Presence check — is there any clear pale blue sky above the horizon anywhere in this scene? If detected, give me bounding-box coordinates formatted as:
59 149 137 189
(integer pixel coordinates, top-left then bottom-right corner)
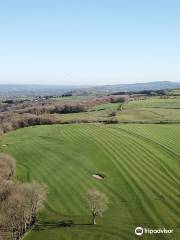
0 0 180 85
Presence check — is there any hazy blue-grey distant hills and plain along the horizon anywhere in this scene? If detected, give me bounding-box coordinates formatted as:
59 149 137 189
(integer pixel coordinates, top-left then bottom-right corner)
0 81 180 98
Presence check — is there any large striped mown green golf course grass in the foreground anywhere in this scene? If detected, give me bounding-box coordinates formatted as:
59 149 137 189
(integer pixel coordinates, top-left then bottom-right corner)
0 124 180 240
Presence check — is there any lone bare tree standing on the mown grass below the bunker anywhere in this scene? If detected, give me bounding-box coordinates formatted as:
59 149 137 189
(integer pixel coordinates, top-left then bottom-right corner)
86 190 108 224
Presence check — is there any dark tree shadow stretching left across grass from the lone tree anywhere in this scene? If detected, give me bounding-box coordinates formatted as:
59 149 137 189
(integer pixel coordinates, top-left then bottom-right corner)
34 220 92 231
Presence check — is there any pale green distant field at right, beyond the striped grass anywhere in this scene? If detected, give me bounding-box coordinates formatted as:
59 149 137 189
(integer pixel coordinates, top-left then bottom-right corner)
117 97 180 122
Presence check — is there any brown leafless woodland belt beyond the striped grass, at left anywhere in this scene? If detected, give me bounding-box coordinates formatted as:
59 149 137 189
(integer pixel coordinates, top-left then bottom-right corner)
0 95 129 134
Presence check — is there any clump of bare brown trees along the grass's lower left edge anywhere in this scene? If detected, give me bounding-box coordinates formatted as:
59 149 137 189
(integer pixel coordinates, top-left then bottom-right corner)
0 154 47 240
